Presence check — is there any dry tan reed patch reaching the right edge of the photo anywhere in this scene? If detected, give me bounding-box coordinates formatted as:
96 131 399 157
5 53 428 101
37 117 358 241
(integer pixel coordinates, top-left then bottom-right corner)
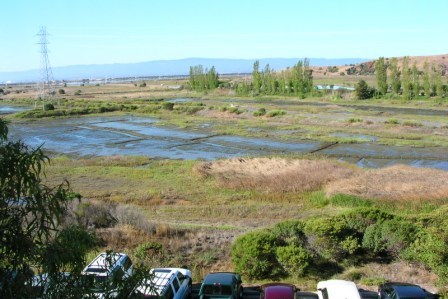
326 165 448 200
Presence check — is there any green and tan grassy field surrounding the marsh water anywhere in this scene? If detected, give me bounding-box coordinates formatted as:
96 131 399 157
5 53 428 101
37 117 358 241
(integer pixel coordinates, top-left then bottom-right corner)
1 76 448 289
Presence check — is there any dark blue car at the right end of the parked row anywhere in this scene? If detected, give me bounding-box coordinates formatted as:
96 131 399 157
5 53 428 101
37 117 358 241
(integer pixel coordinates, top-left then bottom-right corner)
378 282 438 299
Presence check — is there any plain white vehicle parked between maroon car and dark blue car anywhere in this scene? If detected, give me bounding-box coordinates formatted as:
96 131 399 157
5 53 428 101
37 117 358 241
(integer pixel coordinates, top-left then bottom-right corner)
317 279 362 299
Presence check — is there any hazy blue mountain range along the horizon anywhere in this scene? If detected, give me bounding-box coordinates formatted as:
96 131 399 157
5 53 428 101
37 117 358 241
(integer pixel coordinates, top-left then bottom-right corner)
0 58 369 83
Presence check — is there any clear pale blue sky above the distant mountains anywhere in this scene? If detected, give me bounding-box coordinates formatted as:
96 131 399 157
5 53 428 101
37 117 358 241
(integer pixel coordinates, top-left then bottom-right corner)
0 0 448 72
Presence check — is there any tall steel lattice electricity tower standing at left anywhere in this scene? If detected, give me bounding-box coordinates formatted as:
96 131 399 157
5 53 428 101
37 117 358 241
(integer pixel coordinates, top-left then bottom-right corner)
35 27 56 110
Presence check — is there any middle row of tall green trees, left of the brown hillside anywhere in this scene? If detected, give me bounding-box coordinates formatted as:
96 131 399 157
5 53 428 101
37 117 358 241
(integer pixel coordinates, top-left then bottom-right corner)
235 59 313 98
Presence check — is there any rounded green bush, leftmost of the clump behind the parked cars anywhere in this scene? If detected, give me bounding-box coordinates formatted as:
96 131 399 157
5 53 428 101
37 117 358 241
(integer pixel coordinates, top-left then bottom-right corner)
231 231 282 279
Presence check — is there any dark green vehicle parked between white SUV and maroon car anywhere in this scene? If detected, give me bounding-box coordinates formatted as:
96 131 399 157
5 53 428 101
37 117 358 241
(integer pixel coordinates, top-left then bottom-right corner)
199 272 244 299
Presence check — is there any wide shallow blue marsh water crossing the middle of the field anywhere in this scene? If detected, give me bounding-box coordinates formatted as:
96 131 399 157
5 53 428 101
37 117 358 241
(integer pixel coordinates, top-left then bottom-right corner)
9 110 448 171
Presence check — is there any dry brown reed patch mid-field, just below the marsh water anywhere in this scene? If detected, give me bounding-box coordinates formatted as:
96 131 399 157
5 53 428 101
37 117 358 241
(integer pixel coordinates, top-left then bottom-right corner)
194 158 357 192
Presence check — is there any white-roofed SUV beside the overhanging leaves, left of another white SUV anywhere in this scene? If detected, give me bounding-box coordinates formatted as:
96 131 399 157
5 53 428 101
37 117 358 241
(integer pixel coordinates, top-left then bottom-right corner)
81 252 134 298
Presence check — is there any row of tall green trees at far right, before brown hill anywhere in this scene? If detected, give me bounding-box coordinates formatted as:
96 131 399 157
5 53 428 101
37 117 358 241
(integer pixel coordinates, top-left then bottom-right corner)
375 57 446 100
